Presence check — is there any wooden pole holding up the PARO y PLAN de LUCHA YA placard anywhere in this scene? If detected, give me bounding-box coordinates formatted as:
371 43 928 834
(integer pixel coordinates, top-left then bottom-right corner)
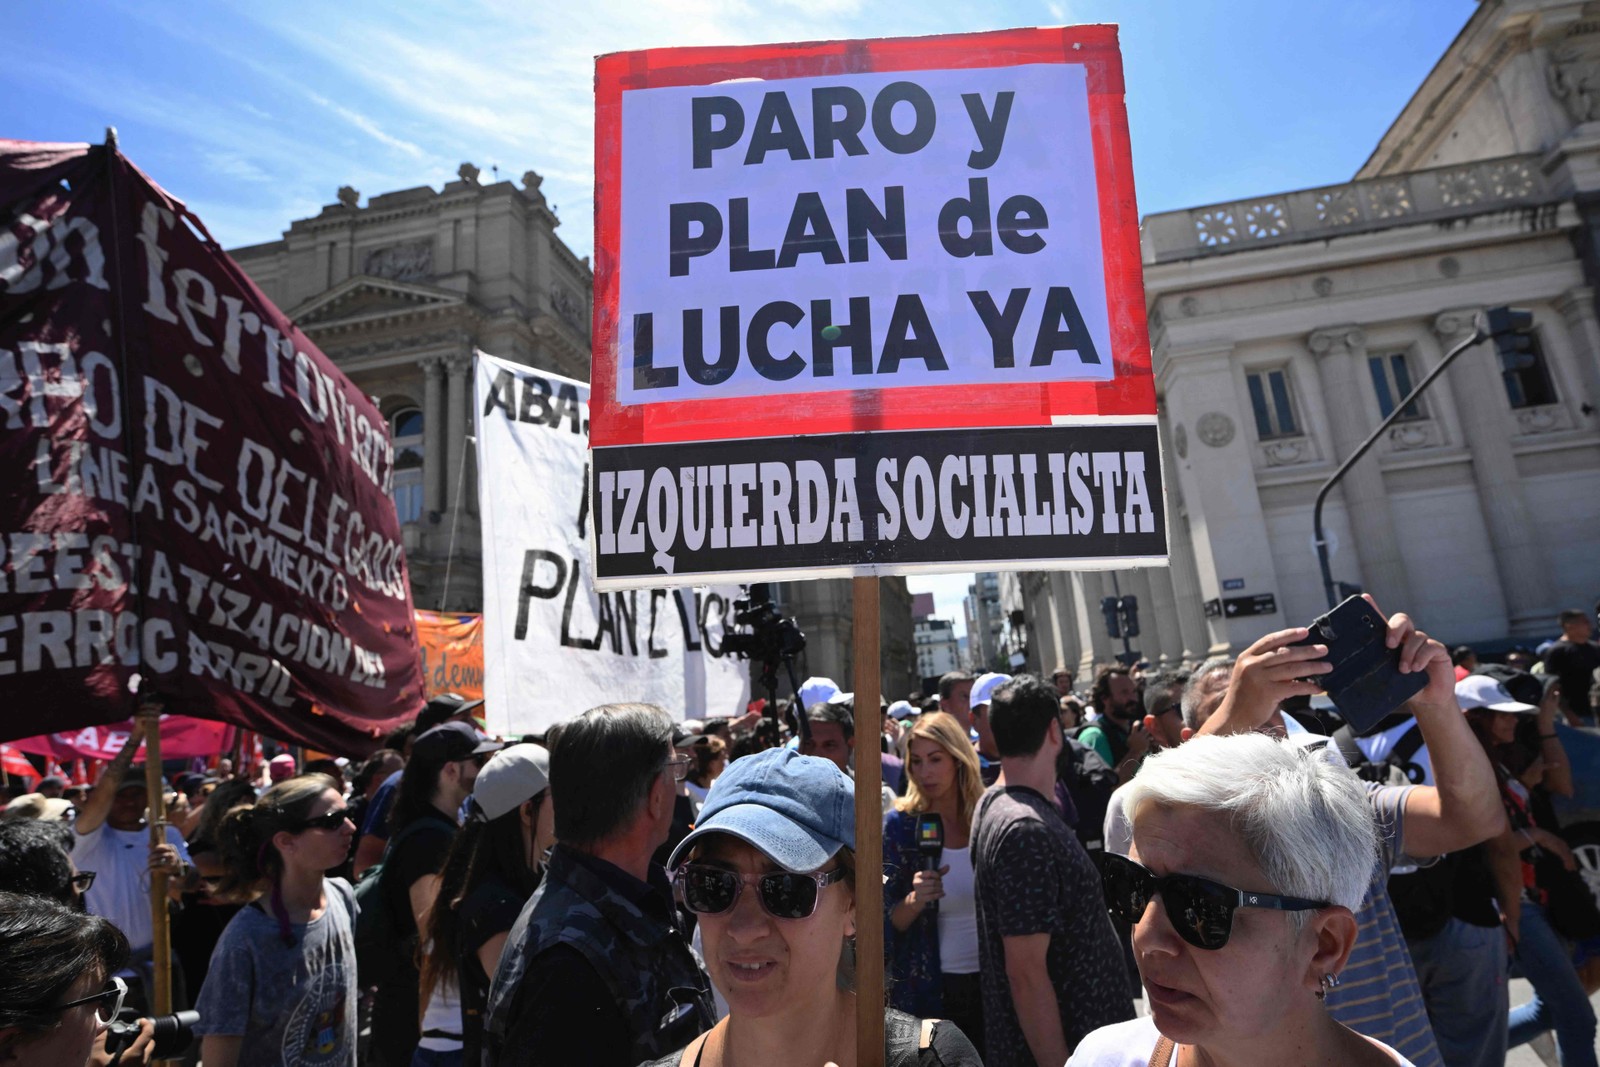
851 577 883 1067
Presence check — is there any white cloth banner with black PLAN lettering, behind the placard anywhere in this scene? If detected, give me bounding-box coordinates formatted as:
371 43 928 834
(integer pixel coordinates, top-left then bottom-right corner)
474 352 750 734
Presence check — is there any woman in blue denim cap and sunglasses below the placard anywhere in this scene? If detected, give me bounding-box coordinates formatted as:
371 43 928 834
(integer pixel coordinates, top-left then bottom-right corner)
633 749 981 1067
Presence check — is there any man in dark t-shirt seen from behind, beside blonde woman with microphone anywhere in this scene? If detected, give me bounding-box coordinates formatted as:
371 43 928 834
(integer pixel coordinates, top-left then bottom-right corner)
973 675 1133 1067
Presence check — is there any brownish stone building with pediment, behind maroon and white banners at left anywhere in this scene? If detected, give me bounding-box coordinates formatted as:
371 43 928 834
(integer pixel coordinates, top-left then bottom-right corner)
229 171 917 696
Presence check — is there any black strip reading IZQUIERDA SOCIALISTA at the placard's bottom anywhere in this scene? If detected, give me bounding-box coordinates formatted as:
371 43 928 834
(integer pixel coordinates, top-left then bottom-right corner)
590 426 1166 584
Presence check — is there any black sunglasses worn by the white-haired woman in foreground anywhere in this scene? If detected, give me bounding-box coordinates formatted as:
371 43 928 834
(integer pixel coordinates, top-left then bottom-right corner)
1096 853 1330 949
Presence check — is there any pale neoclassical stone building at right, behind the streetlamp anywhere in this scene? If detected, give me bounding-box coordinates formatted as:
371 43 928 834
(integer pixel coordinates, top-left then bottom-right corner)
1006 0 1600 669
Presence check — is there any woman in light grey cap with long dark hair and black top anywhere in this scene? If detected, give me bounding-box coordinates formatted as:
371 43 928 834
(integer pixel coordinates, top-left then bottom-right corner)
416 744 555 1067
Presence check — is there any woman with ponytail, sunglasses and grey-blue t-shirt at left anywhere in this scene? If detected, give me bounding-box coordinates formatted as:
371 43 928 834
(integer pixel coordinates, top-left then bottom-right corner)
195 774 357 1067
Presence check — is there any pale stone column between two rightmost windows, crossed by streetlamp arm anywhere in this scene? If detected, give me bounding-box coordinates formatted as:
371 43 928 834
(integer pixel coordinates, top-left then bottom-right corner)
1433 307 1555 637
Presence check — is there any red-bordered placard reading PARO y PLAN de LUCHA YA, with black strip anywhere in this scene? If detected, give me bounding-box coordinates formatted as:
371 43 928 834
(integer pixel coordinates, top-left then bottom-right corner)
592 26 1166 589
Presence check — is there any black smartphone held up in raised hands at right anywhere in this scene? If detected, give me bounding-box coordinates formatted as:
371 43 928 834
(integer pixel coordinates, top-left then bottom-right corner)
1294 597 1427 734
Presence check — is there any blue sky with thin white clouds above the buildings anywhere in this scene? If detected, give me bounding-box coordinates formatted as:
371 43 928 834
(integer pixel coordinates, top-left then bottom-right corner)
0 0 1475 630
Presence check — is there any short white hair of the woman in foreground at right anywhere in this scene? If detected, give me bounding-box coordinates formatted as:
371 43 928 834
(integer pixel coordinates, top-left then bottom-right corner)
1123 733 1378 929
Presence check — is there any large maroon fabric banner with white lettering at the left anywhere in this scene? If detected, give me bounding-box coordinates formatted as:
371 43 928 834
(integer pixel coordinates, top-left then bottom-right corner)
0 141 422 755
